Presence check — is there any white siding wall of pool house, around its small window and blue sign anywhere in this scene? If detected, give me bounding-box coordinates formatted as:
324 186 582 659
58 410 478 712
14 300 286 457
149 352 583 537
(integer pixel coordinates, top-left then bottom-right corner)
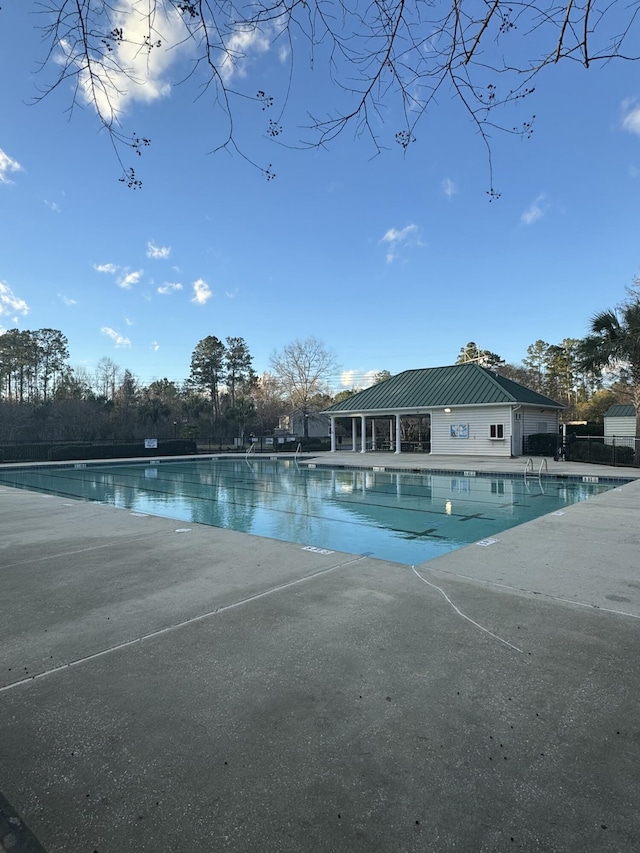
431 406 511 456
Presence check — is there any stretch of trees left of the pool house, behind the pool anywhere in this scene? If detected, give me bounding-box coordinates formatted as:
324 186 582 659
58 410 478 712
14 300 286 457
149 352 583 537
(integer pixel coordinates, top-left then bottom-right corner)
0 329 337 443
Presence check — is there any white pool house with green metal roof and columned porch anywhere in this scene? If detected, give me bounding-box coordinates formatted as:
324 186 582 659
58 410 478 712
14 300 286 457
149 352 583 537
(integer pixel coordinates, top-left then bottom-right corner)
324 363 563 456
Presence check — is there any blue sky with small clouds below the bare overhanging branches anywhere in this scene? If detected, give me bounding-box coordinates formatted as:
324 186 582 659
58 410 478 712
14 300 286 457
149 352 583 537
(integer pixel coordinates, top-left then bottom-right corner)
0 2 640 390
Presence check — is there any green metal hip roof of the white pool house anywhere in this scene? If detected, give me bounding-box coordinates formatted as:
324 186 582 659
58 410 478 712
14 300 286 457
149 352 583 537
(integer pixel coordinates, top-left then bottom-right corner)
326 364 563 415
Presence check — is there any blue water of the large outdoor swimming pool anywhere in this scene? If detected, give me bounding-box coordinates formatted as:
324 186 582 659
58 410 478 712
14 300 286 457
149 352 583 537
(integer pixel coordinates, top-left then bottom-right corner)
0 458 624 565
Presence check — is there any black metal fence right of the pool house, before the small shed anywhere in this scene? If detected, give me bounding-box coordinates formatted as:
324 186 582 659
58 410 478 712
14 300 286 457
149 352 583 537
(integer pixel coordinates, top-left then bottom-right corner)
522 433 640 467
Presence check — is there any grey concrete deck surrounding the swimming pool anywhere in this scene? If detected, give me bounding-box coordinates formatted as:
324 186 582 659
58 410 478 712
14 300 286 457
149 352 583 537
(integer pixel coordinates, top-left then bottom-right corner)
0 452 640 853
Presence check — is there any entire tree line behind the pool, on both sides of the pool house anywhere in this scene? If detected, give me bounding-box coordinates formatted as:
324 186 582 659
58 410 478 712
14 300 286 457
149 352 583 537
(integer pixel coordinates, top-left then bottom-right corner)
0 291 640 443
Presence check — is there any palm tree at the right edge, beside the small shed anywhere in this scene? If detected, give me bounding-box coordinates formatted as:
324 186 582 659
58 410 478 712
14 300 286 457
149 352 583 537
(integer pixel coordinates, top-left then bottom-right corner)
578 298 640 438
